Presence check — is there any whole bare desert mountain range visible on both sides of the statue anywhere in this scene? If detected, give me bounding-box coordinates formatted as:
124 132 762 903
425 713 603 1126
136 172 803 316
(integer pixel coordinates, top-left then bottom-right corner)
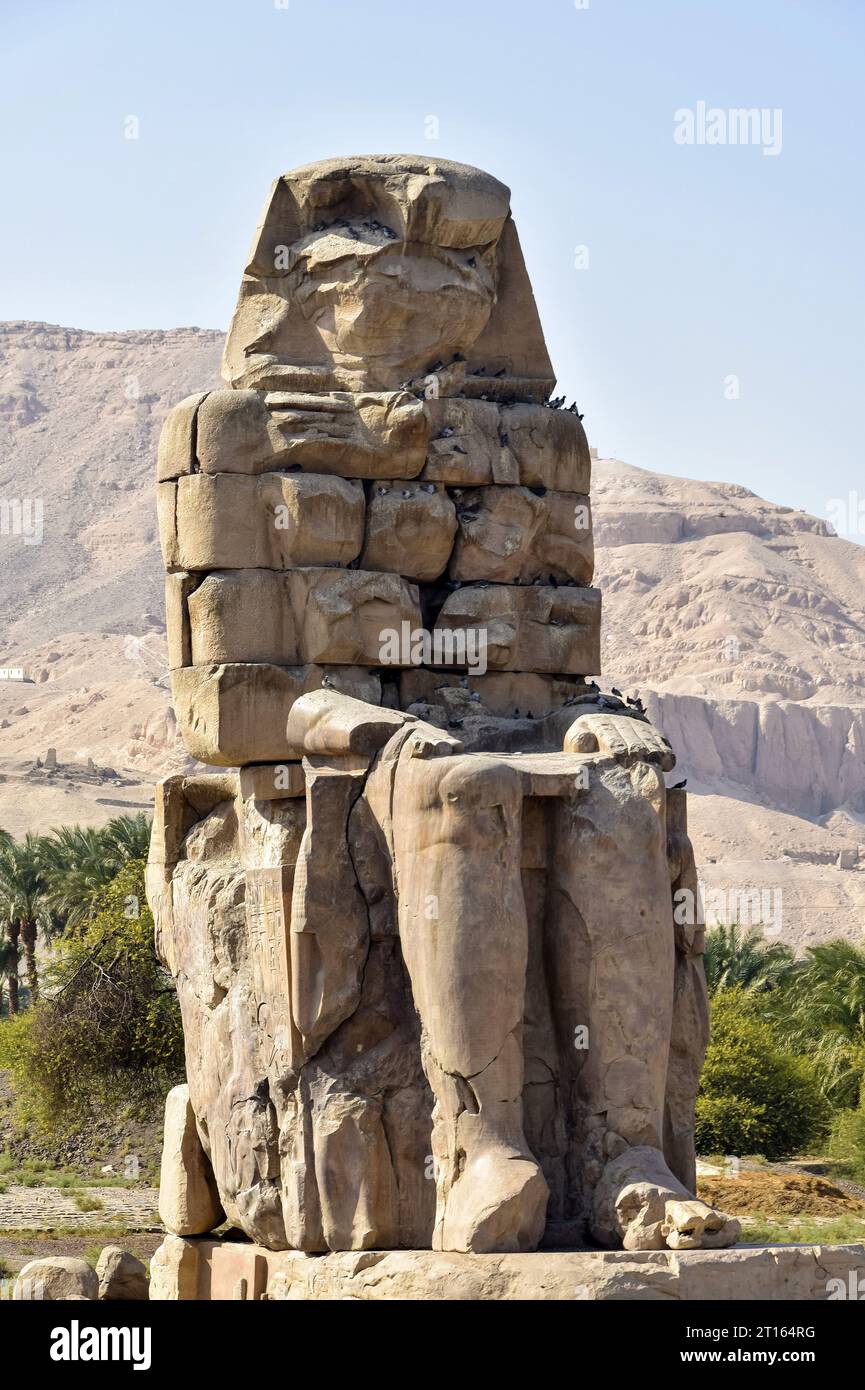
0 322 865 941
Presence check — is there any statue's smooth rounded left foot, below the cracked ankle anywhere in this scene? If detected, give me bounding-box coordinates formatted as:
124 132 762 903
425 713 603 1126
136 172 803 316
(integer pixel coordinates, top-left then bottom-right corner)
441 1148 549 1255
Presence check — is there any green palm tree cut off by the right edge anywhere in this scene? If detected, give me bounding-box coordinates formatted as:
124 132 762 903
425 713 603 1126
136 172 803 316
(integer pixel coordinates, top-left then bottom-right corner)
779 937 865 1108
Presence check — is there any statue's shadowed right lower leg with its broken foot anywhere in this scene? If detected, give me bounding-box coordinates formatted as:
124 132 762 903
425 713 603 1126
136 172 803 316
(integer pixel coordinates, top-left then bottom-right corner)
549 762 738 1250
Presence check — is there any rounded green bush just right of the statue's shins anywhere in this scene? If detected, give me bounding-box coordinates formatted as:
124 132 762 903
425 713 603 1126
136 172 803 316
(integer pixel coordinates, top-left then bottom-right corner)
697 987 827 1159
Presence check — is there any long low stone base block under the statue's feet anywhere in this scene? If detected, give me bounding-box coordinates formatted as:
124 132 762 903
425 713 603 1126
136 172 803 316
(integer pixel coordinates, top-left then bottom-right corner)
150 1236 865 1302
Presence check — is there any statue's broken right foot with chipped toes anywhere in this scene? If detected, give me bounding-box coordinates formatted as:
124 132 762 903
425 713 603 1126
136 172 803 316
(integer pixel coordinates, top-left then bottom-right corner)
591 1147 741 1250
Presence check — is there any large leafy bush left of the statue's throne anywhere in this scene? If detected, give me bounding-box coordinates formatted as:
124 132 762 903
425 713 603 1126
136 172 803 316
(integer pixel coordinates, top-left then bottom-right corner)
0 860 184 1127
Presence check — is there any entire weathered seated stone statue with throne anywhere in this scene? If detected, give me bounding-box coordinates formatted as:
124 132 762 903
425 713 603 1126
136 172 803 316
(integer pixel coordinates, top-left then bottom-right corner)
149 156 738 1252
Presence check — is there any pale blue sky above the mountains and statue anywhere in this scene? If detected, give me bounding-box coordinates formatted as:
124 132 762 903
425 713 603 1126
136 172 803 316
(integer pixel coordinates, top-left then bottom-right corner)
0 0 865 516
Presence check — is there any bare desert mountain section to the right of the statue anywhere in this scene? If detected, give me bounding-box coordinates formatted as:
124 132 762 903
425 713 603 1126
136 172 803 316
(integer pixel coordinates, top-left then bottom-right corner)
592 459 865 942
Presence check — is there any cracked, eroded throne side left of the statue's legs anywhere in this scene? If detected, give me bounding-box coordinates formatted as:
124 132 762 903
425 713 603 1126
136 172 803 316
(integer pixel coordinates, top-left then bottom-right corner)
149 765 435 1251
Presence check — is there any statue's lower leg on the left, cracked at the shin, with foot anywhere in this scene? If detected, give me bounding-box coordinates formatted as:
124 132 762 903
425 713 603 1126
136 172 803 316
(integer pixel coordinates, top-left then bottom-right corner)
394 755 548 1251
